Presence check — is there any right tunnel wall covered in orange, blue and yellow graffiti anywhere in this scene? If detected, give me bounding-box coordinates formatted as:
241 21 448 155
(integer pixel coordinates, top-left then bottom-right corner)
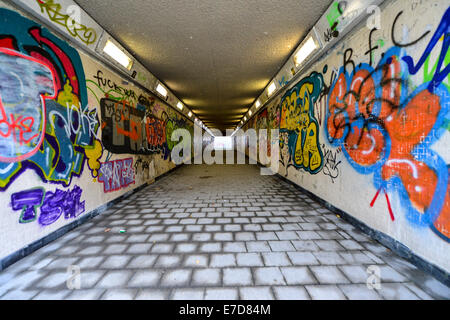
243 0 450 272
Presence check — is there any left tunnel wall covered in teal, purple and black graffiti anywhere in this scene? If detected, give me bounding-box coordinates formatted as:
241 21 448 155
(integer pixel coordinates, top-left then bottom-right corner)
0 5 194 259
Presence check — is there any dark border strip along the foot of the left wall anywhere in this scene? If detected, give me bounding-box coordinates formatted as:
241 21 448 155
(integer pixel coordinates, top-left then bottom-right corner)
0 164 184 271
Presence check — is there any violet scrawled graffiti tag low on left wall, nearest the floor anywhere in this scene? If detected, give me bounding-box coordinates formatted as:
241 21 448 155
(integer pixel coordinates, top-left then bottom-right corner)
11 186 85 226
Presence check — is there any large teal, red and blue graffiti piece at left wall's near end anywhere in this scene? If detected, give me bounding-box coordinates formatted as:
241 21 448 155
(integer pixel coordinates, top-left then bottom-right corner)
0 9 99 190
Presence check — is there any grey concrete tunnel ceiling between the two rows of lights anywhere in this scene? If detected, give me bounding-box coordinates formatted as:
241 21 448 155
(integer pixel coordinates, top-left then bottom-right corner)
76 0 333 130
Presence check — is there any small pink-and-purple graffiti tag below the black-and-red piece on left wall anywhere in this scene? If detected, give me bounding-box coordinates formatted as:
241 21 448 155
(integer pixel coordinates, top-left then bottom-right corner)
98 158 134 192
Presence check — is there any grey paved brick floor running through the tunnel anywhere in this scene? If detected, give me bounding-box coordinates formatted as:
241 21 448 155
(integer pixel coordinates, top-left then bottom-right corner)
0 165 450 299
